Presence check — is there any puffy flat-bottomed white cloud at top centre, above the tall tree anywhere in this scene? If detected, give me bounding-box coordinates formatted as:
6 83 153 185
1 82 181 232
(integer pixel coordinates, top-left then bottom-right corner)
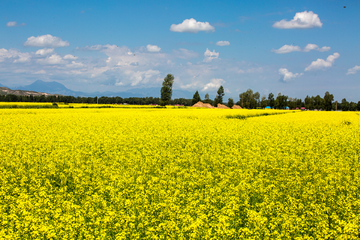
170 18 215 33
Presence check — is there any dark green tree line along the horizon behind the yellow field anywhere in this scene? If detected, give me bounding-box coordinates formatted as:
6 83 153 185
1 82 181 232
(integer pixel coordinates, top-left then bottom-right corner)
0 86 360 111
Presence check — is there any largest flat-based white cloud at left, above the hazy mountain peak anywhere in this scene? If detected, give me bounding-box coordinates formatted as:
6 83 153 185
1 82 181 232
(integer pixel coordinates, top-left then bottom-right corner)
24 34 70 48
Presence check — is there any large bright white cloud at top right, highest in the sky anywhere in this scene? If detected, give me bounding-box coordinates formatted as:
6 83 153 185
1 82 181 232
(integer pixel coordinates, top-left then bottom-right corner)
273 11 322 29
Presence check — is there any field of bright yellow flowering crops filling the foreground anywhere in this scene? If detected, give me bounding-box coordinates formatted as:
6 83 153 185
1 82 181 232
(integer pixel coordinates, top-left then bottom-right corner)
0 108 360 239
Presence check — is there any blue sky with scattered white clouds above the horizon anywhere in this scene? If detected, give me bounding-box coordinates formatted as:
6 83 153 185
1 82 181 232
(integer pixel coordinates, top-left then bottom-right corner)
0 0 360 101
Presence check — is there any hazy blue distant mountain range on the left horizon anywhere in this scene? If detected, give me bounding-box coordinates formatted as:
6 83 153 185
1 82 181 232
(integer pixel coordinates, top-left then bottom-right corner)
11 80 194 99
